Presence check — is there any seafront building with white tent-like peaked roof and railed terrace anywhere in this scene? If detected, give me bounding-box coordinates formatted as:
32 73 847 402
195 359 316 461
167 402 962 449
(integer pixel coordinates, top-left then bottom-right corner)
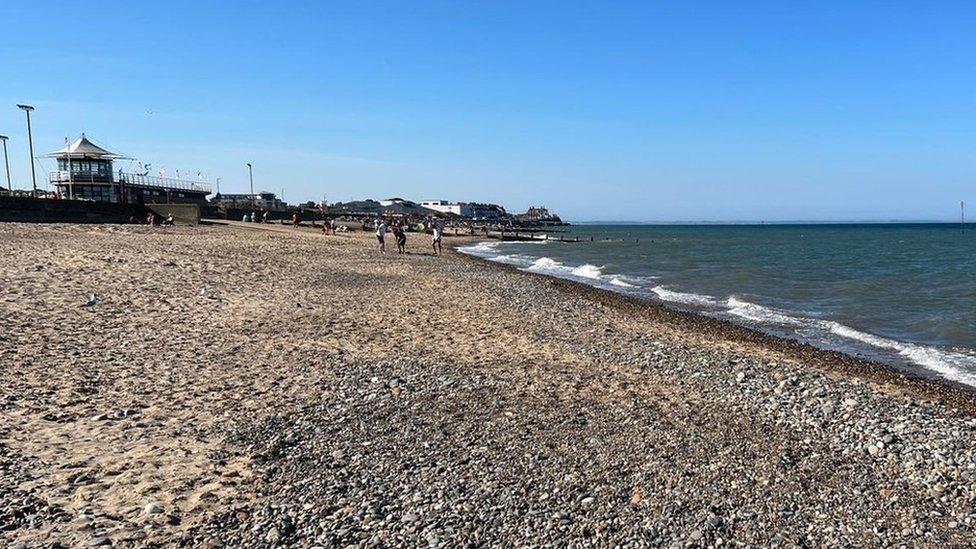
47 134 210 204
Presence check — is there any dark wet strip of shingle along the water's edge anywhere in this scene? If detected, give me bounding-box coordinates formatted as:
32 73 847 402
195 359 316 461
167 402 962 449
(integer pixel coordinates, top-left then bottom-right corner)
451 239 976 414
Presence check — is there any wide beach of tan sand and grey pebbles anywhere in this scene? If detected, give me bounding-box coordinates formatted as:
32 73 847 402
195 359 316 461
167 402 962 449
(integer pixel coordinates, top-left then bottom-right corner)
0 223 976 547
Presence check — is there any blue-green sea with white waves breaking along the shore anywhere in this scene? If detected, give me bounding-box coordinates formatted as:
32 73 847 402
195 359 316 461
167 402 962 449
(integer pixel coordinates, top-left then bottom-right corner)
459 223 976 387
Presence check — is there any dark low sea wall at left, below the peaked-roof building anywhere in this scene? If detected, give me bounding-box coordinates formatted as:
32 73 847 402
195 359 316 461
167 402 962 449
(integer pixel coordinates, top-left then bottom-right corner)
0 196 147 223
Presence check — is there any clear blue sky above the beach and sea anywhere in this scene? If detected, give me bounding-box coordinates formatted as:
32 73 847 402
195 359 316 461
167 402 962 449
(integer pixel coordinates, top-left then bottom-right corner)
0 0 976 221
